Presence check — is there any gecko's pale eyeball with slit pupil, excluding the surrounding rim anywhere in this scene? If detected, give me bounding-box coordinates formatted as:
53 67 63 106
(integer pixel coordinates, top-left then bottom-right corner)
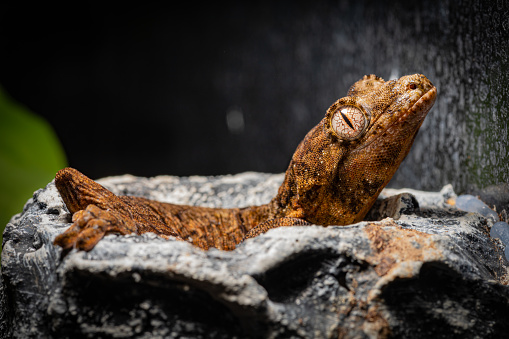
330 106 368 140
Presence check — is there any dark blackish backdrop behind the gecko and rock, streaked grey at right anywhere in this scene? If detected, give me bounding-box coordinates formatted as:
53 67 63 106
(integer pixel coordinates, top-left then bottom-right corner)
0 0 509 192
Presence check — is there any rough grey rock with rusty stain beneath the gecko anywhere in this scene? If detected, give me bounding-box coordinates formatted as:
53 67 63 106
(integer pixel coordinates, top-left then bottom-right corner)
0 173 509 338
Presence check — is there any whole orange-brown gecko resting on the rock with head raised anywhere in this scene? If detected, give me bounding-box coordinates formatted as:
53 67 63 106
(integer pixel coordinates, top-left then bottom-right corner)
54 74 437 251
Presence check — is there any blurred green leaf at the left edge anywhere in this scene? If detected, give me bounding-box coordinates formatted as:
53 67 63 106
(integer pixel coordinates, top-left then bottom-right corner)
0 87 67 247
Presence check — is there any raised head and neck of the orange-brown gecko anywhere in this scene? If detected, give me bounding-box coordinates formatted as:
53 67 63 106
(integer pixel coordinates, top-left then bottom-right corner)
277 74 437 225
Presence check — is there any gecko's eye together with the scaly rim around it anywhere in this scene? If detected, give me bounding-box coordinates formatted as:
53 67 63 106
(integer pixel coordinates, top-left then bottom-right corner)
326 97 370 140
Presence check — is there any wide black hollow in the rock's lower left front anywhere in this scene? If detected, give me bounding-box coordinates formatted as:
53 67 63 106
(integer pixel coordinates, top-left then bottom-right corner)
54 270 249 338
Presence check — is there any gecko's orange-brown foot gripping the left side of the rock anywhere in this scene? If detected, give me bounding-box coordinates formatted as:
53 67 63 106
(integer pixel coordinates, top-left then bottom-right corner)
53 205 136 252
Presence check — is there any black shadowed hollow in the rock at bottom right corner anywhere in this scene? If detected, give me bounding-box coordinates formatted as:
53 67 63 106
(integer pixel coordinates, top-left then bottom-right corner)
381 262 509 338
